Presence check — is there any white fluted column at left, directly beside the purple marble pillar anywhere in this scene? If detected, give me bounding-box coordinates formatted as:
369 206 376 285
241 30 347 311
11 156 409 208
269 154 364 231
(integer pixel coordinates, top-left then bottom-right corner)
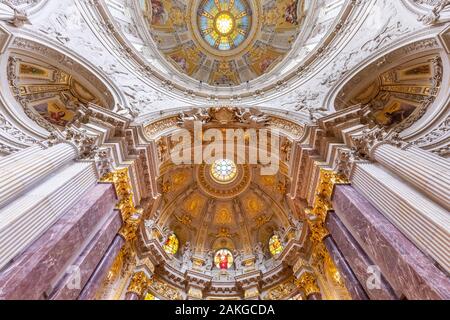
0 161 98 269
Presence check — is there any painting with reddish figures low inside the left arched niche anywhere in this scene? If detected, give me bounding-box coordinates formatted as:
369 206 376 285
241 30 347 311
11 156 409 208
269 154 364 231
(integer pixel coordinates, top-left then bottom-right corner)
29 98 75 128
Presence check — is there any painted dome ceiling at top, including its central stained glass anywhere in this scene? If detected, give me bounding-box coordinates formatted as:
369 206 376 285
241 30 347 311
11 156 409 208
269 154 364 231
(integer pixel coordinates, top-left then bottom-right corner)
140 0 305 86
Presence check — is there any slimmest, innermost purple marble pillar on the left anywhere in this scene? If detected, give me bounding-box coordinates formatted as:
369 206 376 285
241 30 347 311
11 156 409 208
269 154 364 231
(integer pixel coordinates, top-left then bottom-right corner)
78 235 125 300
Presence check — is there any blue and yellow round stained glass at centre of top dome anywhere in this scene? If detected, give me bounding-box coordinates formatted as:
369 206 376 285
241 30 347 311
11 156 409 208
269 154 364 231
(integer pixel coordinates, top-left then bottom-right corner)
198 0 252 51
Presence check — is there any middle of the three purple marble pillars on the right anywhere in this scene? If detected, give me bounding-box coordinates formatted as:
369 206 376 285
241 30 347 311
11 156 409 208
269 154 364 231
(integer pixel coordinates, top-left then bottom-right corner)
326 212 399 300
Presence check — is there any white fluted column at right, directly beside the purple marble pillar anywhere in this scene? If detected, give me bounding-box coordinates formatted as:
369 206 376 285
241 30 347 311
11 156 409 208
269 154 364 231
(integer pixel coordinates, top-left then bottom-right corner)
352 163 450 272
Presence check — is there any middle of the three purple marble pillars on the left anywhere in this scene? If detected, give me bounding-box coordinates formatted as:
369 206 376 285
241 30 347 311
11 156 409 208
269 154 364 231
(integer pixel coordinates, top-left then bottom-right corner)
50 211 122 300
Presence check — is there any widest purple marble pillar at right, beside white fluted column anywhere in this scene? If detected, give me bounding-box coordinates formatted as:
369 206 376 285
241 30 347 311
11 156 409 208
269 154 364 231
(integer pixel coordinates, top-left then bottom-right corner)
333 186 450 300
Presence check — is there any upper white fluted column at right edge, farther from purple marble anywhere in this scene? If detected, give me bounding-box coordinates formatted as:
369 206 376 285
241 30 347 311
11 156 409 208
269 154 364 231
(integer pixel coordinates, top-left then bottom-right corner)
372 144 450 210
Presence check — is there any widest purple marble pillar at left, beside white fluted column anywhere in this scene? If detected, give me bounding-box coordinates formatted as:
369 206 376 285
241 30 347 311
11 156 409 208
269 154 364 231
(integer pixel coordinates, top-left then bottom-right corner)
0 184 117 300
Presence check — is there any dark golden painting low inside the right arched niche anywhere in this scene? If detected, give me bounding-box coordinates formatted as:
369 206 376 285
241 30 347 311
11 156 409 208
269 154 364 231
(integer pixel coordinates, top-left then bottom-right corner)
372 100 417 127
